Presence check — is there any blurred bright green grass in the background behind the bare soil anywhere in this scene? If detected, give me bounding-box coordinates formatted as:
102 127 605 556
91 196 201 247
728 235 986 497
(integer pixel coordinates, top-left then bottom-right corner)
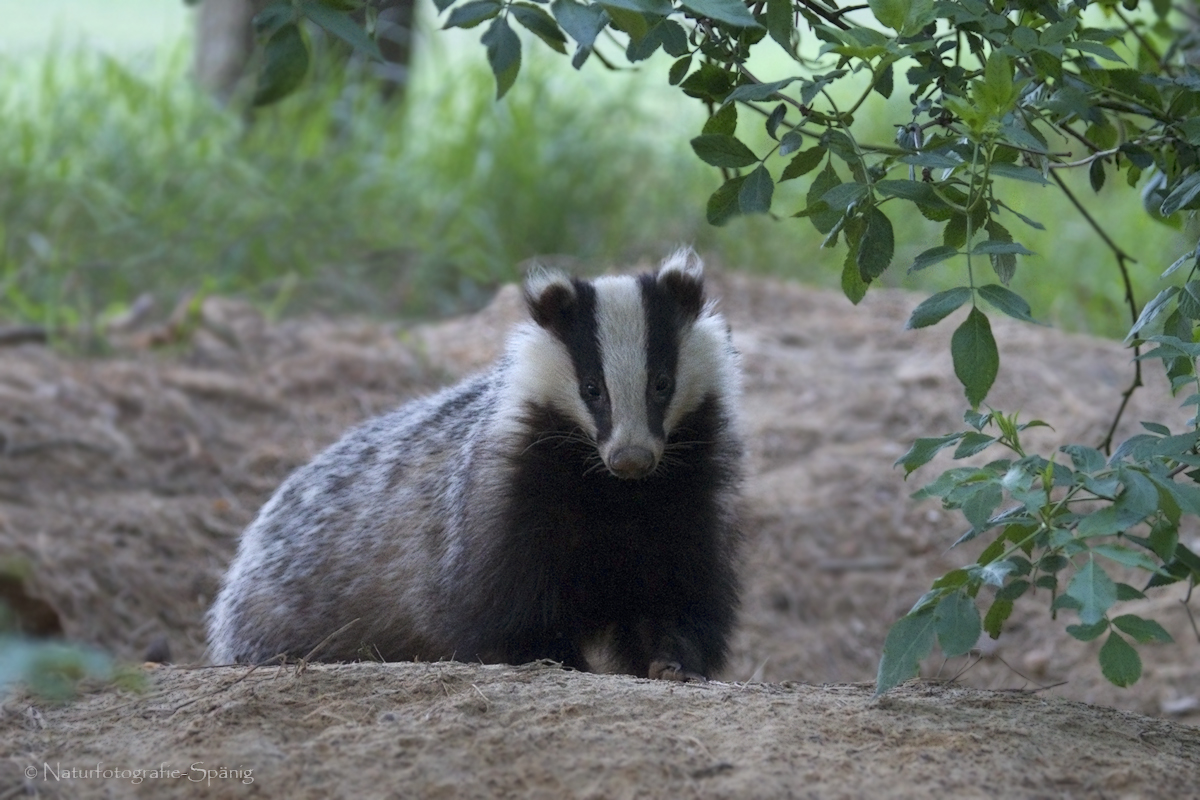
0 24 1184 336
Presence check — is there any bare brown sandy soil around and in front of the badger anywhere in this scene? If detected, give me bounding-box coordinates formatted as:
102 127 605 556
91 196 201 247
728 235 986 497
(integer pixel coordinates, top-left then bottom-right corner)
0 276 1200 798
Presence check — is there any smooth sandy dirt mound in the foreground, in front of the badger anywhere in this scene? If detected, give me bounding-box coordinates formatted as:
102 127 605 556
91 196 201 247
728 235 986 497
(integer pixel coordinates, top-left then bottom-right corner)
9 663 1200 800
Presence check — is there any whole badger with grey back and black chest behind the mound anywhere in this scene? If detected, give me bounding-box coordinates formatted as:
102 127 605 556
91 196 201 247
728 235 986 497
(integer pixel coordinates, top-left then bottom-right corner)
209 249 743 680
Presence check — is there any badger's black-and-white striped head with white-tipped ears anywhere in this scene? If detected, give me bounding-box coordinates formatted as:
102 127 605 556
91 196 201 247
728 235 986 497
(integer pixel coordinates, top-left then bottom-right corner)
501 249 738 480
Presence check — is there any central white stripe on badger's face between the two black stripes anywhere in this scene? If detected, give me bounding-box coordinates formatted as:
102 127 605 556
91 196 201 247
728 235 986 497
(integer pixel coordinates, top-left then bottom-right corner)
595 277 662 456
